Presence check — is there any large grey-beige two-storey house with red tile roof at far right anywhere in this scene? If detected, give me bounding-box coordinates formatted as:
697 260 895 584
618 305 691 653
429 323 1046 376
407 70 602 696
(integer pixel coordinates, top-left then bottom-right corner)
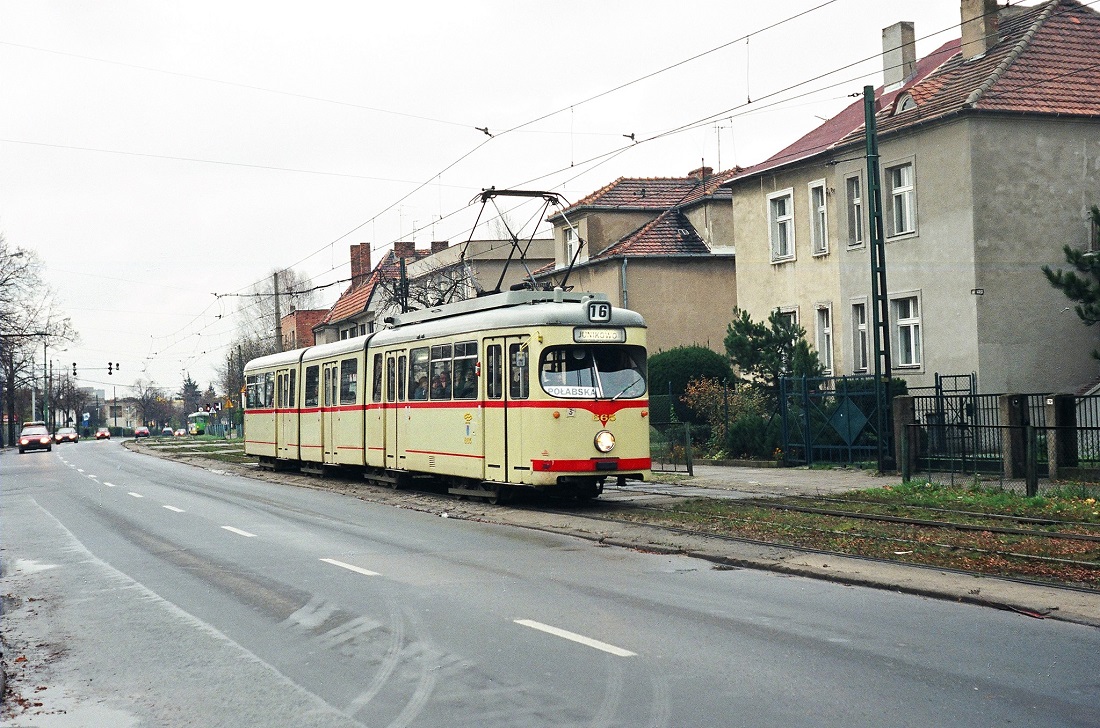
726 0 1100 393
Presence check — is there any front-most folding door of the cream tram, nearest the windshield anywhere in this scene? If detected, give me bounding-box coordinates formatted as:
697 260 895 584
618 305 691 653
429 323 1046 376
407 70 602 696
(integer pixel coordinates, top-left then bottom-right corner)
484 337 531 483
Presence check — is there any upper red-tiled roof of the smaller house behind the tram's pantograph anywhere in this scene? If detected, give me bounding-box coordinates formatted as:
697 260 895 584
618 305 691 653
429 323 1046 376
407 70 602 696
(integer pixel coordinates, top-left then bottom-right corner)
548 168 739 222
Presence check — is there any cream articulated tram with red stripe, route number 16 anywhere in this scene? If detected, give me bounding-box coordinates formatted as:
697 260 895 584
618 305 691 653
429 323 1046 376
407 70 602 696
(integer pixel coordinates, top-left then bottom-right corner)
244 288 650 501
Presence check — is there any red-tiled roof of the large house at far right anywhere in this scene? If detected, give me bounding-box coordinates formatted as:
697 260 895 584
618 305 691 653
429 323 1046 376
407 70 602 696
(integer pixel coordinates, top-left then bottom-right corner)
740 0 1100 177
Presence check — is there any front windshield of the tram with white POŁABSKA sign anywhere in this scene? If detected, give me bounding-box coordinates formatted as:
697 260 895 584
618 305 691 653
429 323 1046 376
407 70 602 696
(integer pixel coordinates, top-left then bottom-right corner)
539 344 646 399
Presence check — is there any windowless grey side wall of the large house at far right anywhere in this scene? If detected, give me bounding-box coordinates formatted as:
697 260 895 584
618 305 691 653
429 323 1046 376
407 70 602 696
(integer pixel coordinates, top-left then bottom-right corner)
969 118 1100 391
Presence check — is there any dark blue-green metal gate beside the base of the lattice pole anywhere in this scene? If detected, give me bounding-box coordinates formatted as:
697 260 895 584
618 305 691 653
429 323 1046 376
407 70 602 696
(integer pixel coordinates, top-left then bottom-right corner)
779 376 892 465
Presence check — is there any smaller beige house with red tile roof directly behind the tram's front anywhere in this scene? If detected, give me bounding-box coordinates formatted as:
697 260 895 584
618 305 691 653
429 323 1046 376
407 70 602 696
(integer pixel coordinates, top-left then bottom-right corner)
534 167 737 352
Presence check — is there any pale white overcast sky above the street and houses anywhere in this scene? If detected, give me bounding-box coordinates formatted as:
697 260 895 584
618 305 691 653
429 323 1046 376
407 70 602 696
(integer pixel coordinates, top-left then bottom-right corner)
0 0 994 396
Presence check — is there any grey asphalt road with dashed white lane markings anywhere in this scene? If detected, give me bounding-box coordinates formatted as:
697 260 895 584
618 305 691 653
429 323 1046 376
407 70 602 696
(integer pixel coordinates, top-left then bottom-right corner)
0 441 1100 728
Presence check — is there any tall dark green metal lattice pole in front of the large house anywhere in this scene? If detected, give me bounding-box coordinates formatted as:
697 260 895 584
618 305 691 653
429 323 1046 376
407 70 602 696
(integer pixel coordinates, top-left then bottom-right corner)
864 86 894 473
